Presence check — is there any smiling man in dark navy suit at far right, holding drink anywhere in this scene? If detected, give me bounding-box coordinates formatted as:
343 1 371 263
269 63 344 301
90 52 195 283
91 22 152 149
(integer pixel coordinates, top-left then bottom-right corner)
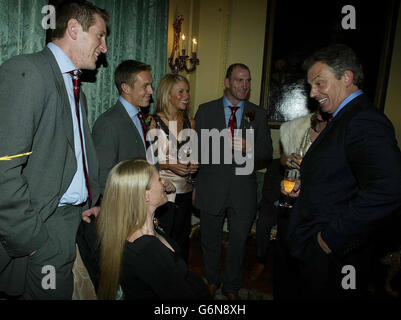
288 44 401 299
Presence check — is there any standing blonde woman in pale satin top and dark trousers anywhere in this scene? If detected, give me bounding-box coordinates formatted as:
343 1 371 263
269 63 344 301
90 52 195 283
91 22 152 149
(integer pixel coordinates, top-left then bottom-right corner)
150 73 199 262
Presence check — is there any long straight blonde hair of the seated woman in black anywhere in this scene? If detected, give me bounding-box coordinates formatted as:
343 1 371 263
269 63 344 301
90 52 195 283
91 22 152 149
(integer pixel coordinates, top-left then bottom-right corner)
97 158 156 299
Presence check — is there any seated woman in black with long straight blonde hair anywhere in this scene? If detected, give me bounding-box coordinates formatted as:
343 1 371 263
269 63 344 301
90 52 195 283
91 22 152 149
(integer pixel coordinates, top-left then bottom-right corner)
97 159 210 300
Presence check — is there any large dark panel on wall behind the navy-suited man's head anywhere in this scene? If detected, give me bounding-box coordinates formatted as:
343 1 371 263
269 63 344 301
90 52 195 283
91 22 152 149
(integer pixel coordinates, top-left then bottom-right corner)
265 0 399 121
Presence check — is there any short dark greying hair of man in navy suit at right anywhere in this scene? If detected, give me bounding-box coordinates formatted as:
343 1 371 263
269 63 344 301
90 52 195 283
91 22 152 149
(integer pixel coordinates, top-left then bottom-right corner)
303 43 364 88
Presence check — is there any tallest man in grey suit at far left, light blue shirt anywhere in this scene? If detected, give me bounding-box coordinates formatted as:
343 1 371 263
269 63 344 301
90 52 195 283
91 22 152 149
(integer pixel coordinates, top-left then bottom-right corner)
0 1 108 299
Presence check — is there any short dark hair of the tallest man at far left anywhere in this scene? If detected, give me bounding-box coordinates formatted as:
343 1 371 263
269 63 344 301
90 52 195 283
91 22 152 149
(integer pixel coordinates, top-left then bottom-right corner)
52 0 110 39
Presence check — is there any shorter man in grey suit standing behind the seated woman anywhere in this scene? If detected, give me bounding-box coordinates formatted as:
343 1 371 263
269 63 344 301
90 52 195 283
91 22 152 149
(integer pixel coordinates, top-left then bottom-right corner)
92 60 153 190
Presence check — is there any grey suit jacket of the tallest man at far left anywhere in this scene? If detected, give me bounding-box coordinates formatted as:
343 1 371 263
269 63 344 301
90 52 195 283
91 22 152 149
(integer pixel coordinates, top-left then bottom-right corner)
0 48 99 294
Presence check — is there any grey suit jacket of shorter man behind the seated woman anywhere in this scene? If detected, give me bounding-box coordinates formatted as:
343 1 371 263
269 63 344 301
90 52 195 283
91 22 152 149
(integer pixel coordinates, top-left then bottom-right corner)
92 100 146 193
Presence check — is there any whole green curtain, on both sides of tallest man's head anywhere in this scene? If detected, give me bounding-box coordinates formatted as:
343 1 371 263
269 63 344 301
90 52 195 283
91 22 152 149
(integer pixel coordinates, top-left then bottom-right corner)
0 0 168 126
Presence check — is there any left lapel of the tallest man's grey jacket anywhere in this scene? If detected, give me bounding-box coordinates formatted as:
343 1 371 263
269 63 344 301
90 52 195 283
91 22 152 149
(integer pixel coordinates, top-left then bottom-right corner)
43 48 75 152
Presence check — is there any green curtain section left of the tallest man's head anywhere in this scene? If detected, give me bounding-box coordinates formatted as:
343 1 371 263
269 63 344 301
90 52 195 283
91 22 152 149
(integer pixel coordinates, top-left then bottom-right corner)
0 0 47 65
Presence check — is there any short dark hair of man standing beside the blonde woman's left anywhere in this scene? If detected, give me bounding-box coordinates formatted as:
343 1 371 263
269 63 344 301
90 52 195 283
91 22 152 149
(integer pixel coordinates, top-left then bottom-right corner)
114 60 152 94
